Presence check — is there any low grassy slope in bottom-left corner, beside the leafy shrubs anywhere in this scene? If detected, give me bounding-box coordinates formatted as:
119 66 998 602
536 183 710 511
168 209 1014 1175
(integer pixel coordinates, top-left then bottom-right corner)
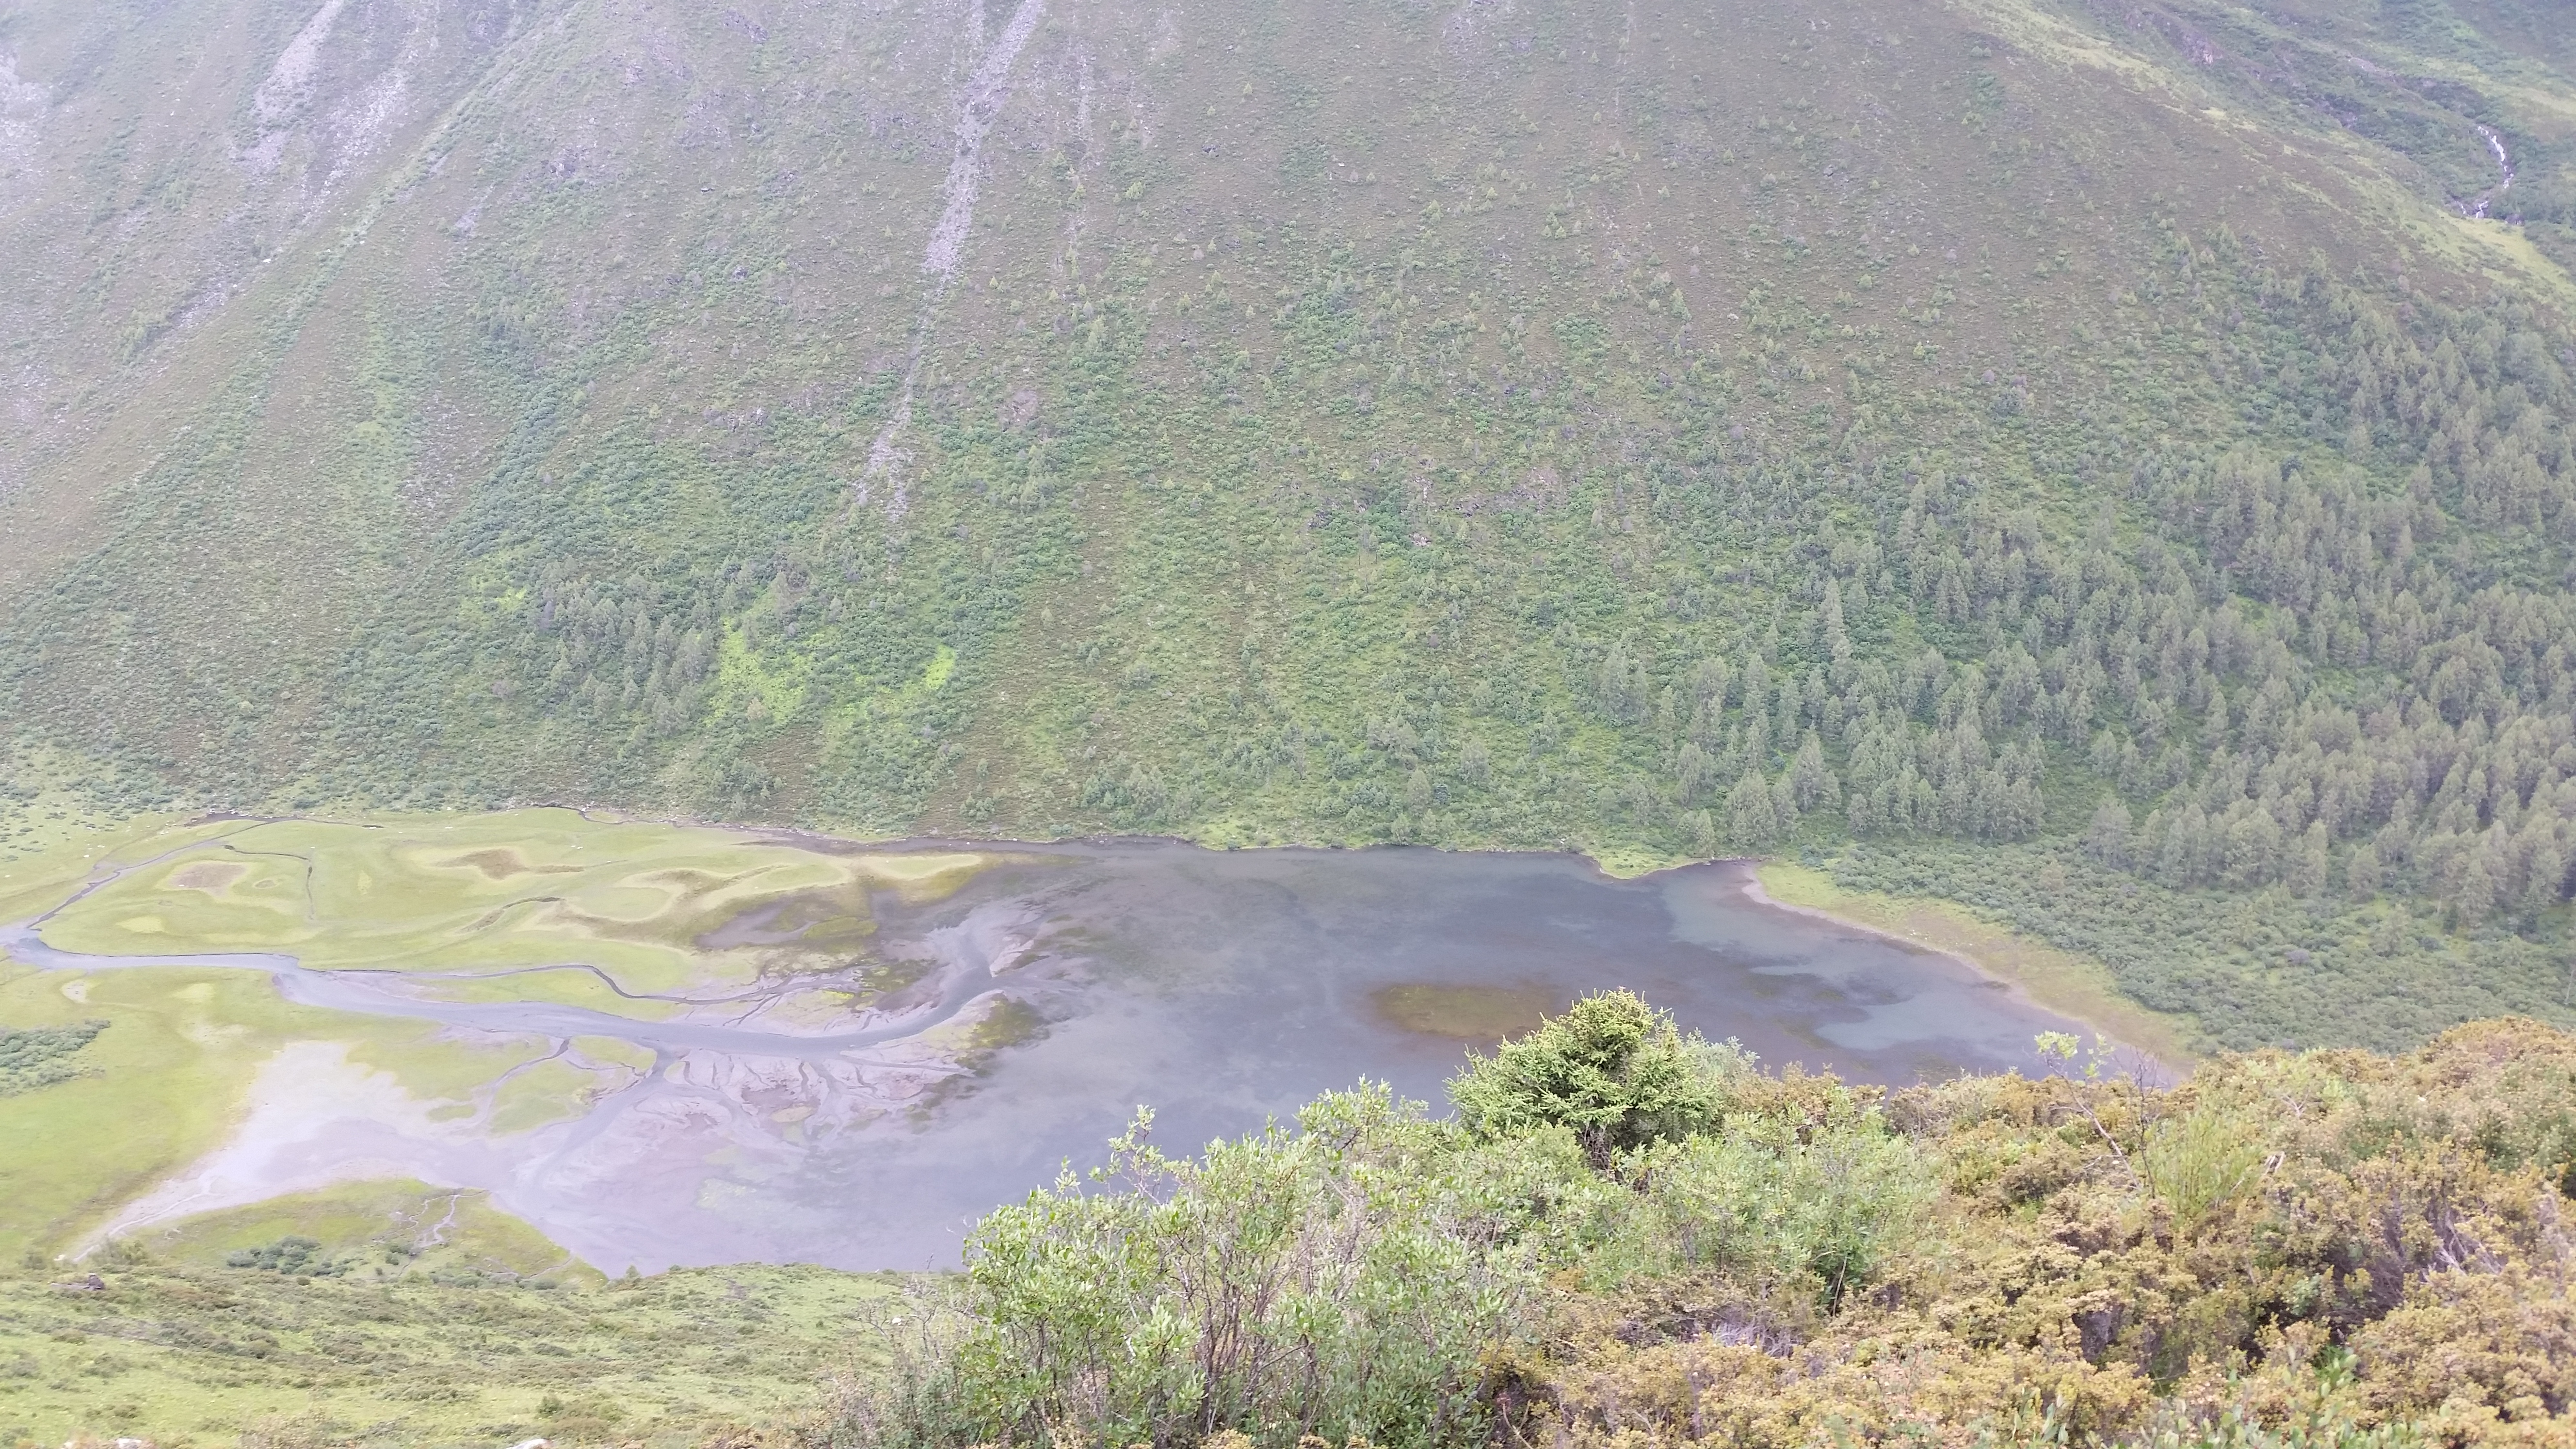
0 1238 889 1449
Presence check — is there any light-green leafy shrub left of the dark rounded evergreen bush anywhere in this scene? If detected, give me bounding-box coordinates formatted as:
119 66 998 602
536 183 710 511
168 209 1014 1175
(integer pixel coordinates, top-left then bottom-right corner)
842 1088 1538 1447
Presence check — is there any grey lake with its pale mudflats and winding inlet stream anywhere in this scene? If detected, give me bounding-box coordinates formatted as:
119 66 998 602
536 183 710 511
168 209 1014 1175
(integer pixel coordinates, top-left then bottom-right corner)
15 840 2076 1273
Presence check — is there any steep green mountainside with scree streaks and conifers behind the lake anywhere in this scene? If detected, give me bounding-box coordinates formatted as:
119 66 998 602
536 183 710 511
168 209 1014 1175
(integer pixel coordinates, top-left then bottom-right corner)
0 0 2576 1047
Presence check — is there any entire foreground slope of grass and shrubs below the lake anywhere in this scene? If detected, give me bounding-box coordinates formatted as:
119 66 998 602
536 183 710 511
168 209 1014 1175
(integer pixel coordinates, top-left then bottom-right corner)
0 993 2576 1449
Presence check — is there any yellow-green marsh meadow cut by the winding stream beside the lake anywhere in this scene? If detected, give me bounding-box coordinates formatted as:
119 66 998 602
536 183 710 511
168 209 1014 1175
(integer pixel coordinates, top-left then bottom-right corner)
0 809 1035 1256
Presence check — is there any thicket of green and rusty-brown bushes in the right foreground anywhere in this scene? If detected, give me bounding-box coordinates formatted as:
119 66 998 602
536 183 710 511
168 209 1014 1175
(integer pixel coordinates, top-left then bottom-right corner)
822 998 2576 1449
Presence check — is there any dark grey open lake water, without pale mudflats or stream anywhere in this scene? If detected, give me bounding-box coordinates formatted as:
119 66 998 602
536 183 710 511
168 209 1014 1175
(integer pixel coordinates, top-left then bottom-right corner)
783 843 2079 1266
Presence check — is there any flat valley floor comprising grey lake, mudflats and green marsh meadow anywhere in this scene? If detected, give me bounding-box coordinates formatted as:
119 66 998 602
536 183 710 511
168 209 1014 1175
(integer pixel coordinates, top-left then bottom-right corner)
0 809 2079 1273
